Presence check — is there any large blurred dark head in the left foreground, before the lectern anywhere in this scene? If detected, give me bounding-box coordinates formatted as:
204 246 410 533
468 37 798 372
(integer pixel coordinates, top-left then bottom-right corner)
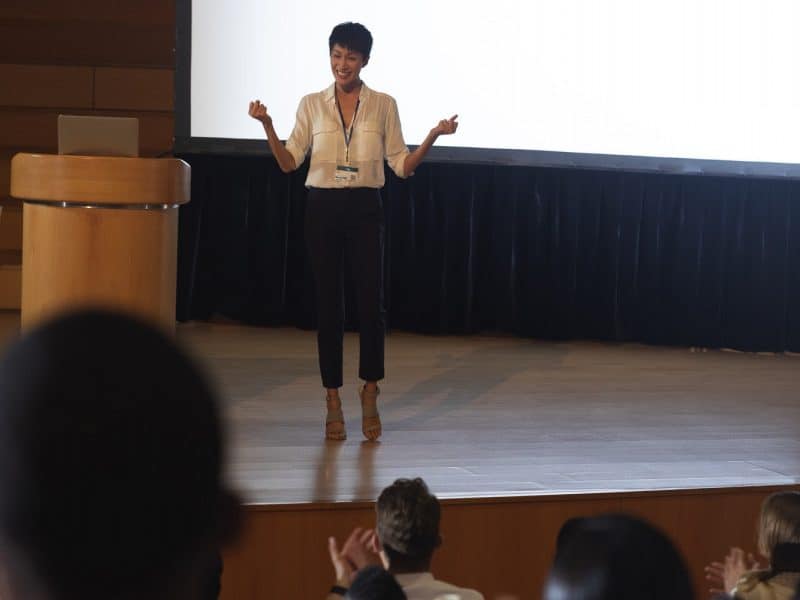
0 311 239 600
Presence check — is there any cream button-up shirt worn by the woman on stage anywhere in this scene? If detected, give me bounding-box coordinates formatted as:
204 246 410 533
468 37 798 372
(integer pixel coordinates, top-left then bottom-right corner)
286 83 409 188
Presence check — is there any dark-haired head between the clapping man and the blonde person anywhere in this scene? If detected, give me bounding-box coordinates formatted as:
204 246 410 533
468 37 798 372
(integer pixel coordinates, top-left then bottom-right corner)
544 515 693 600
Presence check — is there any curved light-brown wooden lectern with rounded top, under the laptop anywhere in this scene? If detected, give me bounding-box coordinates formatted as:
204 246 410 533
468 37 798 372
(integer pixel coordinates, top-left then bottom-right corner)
11 154 190 330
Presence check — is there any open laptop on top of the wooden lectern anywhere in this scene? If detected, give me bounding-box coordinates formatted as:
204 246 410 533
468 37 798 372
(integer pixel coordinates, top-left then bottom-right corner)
58 115 139 157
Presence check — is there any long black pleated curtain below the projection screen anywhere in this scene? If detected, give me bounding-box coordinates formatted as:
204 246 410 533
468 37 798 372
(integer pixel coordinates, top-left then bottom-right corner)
177 156 800 352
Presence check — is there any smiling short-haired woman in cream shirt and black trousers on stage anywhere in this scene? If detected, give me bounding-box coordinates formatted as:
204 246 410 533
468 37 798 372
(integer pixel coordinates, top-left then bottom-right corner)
249 23 458 441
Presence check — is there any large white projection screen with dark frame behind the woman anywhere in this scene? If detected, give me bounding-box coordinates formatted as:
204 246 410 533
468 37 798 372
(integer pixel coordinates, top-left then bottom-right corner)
176 0 800 178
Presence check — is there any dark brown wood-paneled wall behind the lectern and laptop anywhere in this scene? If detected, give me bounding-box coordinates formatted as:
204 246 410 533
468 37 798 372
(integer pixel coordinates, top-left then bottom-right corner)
0 0 175 304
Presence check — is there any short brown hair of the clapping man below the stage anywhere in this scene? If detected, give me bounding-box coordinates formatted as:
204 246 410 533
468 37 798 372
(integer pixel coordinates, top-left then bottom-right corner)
375 477 441 568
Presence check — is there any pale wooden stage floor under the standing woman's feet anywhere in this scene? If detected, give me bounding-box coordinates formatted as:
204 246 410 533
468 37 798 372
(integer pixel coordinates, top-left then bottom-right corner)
173 323 800 505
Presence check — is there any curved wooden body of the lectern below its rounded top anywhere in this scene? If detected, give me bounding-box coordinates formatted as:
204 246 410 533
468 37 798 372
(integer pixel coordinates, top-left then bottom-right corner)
22 202 178 328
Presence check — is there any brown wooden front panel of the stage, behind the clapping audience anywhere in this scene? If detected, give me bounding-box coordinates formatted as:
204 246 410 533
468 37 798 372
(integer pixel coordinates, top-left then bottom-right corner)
222 488 789 600
